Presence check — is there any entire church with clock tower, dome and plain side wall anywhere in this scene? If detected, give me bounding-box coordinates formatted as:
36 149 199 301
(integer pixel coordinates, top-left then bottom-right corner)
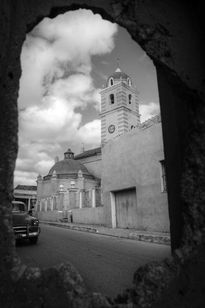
37 68 169 232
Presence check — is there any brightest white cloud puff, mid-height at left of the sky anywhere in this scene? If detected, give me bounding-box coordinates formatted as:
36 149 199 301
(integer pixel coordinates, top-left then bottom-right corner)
20 97 81 141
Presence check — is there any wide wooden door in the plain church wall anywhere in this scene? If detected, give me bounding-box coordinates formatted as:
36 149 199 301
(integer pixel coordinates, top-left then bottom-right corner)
115 188 137 228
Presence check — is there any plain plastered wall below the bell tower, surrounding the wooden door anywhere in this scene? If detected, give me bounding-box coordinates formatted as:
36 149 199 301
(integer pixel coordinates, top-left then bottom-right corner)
102 123 169 232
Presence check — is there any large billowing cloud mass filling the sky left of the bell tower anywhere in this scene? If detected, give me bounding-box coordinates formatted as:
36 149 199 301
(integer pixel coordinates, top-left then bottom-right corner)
15 10 117 185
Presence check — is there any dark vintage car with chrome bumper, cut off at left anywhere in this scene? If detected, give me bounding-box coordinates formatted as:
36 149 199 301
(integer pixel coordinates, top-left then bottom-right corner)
12 201 40 244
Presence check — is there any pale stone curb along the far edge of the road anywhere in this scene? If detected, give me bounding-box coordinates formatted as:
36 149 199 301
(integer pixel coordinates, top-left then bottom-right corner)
40 221 170 246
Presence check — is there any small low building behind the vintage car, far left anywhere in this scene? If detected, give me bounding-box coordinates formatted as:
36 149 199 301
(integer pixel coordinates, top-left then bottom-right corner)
14 185 37 211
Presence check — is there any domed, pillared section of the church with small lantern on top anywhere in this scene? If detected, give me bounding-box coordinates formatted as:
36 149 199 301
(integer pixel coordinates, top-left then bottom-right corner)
37 149 101 218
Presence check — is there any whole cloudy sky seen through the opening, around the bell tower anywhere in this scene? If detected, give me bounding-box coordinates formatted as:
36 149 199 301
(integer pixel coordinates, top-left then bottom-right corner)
14 10 159 186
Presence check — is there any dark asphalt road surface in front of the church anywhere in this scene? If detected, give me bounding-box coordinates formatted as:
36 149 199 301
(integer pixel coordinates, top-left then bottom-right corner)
16 225 170 298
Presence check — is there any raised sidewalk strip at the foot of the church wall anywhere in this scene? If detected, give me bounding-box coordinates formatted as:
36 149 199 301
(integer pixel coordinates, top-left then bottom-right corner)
40 221 170 245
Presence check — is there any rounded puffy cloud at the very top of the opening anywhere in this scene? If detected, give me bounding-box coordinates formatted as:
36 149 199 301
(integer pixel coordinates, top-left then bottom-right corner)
33 9 117 57
